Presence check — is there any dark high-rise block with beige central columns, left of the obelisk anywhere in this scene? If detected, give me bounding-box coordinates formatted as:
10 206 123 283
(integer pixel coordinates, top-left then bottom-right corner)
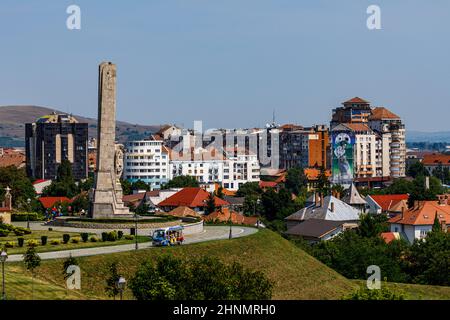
25 113 88 180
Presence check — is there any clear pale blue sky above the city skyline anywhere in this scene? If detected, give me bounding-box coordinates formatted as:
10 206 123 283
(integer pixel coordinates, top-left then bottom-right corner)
0 0 450 131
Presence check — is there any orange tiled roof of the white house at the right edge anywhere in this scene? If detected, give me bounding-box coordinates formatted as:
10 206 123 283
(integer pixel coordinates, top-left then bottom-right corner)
389 201 450 225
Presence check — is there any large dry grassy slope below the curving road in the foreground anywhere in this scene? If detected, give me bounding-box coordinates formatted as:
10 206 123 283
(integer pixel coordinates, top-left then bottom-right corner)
3 230 450 300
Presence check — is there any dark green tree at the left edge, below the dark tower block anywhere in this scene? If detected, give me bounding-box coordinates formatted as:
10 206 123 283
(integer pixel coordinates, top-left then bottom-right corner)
0 166 39 208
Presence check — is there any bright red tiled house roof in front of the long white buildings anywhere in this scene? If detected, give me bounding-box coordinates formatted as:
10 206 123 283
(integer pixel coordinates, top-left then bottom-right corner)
159 188 229 208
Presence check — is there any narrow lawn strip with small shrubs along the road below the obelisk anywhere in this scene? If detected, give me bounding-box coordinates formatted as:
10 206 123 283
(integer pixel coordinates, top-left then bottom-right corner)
0 233 151 255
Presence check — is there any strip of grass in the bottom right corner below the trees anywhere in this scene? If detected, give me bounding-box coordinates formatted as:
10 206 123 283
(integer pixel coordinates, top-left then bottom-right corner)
354 280 450 300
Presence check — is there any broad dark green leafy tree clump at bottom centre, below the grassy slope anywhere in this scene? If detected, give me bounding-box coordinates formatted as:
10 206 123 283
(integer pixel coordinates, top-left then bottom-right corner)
129 255 273 300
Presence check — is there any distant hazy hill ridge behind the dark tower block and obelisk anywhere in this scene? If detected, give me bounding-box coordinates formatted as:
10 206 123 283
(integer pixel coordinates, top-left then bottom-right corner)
0 106 161 147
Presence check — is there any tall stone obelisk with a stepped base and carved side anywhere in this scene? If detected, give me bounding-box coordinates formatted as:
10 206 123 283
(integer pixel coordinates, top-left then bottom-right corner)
90 62 130 219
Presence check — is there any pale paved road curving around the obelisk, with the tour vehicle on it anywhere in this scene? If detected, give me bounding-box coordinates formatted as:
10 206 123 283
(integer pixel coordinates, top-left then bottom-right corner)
7 225 258 262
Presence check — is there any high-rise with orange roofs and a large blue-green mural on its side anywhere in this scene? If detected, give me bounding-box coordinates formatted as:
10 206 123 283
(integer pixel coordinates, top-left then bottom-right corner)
330 97 406 184
